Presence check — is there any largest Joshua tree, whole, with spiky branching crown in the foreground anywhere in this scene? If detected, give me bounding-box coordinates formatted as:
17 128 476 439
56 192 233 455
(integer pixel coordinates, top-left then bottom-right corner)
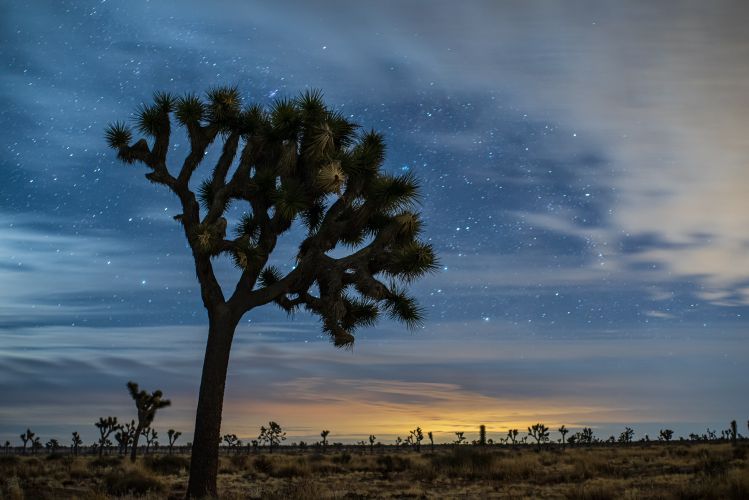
106 88 436 497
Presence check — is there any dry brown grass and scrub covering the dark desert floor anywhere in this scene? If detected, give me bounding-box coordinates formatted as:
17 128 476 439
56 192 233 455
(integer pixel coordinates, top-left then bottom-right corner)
0 443 749 500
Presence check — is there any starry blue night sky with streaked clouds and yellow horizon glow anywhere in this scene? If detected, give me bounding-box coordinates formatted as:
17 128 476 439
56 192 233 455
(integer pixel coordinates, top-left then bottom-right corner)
0 0 749 443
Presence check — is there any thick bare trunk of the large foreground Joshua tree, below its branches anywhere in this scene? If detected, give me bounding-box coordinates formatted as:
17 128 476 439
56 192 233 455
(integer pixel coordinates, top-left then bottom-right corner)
186 307 237 498
